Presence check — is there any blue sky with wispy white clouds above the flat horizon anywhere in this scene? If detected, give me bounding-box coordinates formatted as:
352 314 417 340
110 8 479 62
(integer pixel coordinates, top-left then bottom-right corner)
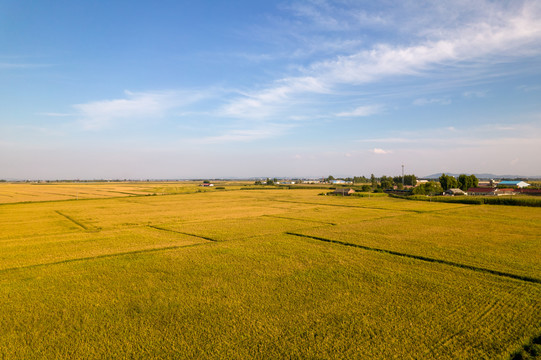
0 0 541 180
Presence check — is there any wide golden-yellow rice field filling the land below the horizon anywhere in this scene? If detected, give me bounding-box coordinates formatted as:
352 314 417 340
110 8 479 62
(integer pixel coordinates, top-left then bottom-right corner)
0 183 541 359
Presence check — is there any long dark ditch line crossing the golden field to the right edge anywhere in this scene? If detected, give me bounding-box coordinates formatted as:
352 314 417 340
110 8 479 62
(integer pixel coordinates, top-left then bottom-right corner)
286 231 541 284
